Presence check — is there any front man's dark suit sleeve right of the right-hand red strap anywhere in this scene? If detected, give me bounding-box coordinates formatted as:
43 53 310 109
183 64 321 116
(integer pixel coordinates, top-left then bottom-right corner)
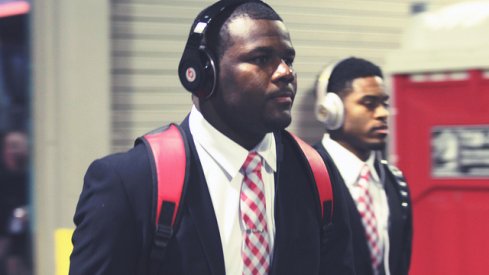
320 161 355 275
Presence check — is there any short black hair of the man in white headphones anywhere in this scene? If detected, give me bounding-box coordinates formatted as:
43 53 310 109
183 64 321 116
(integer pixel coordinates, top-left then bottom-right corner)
327 57 384 97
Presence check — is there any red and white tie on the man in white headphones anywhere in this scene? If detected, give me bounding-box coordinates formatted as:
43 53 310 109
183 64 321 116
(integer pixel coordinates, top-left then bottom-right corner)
355 165 383 274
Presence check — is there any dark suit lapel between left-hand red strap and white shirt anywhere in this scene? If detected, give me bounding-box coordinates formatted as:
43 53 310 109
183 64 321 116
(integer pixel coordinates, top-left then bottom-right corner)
181 117 225 275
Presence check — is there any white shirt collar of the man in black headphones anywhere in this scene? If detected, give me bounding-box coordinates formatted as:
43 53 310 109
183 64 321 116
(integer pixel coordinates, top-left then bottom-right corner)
189 106 277 178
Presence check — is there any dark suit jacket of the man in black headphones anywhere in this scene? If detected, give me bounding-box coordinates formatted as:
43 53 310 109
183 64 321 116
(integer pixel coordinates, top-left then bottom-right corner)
70 120 353 275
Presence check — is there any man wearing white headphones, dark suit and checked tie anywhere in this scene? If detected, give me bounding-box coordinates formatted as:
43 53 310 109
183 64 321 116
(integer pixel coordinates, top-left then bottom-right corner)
315 57 412 275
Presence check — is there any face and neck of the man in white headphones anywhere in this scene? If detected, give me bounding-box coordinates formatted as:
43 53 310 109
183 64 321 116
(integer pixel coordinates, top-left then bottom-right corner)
331 76 389 161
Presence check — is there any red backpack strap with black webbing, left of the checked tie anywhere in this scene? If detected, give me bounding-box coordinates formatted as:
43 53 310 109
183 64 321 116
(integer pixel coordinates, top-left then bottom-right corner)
141 124 188 274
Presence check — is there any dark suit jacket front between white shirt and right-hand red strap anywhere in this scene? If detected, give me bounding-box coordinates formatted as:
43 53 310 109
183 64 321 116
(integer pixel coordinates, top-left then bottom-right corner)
269 132 321 275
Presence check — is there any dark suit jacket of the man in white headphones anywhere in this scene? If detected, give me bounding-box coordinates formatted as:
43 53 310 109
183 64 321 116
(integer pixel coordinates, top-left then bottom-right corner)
314 143 413 275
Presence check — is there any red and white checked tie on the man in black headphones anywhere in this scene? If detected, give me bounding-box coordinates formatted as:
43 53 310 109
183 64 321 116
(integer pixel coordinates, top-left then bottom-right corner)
240 152 270 275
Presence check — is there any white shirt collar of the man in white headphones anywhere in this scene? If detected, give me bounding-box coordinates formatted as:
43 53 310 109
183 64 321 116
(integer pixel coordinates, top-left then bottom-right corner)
321 134 380 185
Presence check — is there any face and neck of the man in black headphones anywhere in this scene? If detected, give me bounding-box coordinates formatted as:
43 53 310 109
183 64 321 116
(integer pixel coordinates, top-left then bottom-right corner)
194 16 297 150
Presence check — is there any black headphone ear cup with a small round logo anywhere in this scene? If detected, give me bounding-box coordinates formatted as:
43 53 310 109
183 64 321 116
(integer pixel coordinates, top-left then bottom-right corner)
178 49 217 98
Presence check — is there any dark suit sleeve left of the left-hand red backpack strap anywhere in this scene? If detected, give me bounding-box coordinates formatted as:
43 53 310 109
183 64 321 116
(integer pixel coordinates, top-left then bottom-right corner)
69 159 141 275
